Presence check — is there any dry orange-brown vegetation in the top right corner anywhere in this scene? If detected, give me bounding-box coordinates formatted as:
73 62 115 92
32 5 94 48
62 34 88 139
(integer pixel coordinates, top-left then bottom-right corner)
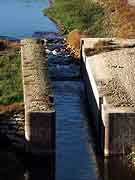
102 0 135 38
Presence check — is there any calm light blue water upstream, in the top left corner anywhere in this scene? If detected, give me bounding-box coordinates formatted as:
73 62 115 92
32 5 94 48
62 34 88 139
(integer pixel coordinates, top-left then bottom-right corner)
0 0 57 38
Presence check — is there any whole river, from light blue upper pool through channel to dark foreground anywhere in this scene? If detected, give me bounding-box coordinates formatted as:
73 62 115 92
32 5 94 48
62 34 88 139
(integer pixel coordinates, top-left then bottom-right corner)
0 0 135 180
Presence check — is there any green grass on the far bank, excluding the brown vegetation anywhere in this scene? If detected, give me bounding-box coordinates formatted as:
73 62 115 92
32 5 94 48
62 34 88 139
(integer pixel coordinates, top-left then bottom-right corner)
44 0 104 36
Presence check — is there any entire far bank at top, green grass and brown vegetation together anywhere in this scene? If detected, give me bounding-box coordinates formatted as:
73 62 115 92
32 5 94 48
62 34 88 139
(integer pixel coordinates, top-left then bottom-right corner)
44 0 135 38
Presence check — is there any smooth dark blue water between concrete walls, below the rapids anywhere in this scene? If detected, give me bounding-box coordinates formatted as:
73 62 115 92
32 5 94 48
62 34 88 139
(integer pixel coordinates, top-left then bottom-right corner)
53 81 96 180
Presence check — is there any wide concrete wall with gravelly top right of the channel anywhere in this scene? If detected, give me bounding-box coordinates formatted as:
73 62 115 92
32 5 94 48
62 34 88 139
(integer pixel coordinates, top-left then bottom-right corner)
82 38 135 156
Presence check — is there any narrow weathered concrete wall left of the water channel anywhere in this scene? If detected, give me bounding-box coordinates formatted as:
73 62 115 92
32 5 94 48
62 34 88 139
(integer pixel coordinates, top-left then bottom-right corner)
21 39 55 154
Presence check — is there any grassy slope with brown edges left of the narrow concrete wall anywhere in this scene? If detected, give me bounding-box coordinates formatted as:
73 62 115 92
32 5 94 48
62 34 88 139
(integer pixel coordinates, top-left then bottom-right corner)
0 40 23 113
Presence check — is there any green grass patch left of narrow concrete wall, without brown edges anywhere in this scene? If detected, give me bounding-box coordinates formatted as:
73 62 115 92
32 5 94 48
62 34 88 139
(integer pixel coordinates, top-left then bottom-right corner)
0 51 23 105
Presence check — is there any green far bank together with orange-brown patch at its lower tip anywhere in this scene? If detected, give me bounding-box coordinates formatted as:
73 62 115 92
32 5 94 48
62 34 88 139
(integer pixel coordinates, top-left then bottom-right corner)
43 0 104 59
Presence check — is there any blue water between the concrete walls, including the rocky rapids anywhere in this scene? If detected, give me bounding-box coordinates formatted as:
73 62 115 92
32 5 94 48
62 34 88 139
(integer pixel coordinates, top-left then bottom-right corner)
48 37 97 180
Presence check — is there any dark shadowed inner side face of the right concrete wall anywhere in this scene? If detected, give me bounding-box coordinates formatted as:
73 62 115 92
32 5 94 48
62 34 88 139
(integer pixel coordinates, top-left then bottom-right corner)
81 61 104 154
